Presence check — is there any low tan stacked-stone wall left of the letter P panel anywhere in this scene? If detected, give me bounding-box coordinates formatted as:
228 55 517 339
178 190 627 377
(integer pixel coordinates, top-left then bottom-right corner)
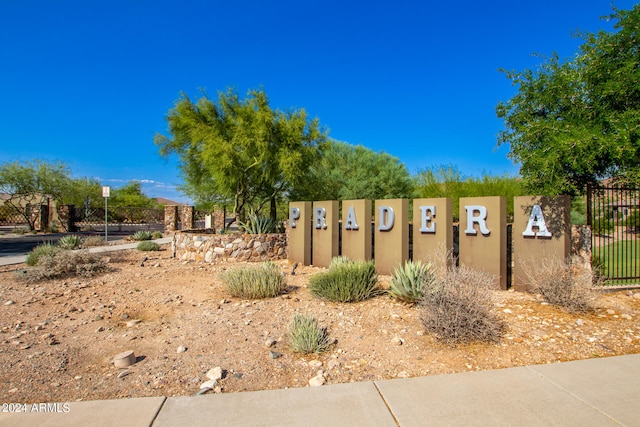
171 232 287 262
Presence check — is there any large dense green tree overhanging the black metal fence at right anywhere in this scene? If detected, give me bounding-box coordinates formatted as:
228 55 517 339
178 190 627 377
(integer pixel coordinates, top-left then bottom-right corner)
496 5 640 194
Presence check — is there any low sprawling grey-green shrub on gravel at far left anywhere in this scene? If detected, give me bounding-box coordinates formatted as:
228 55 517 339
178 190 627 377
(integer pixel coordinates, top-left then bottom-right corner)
17 250 108 282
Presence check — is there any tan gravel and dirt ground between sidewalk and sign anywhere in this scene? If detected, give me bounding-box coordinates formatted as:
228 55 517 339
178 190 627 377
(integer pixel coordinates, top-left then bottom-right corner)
0 245 640 403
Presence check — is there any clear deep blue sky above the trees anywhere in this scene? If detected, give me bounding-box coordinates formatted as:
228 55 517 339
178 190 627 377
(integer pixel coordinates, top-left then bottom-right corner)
0 0 637 201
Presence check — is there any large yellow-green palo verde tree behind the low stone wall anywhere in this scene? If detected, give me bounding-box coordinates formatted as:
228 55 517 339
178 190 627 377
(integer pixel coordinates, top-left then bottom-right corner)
155 89 326 226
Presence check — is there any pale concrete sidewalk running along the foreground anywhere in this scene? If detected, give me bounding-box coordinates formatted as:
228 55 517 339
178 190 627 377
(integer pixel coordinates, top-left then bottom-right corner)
0 354 640 427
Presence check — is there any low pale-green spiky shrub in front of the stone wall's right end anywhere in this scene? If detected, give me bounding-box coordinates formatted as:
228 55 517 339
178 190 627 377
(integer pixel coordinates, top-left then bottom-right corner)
220 261 287 299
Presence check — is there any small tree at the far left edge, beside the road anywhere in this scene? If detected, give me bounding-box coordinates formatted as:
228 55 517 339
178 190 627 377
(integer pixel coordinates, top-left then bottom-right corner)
0 160 71 230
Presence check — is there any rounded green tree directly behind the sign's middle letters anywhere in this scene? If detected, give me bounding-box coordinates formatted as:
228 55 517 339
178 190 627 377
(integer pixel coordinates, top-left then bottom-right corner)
292 141 413 200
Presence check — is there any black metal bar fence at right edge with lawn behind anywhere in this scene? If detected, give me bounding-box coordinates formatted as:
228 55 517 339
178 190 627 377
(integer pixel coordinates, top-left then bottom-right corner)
587 187 640 285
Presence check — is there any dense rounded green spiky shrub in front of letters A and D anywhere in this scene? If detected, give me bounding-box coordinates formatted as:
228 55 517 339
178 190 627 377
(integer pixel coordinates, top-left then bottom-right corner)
309 258 380 302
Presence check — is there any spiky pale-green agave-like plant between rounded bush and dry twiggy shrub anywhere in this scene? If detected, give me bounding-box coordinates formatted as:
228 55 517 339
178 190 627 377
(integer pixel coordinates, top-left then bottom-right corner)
387 260 436 303
